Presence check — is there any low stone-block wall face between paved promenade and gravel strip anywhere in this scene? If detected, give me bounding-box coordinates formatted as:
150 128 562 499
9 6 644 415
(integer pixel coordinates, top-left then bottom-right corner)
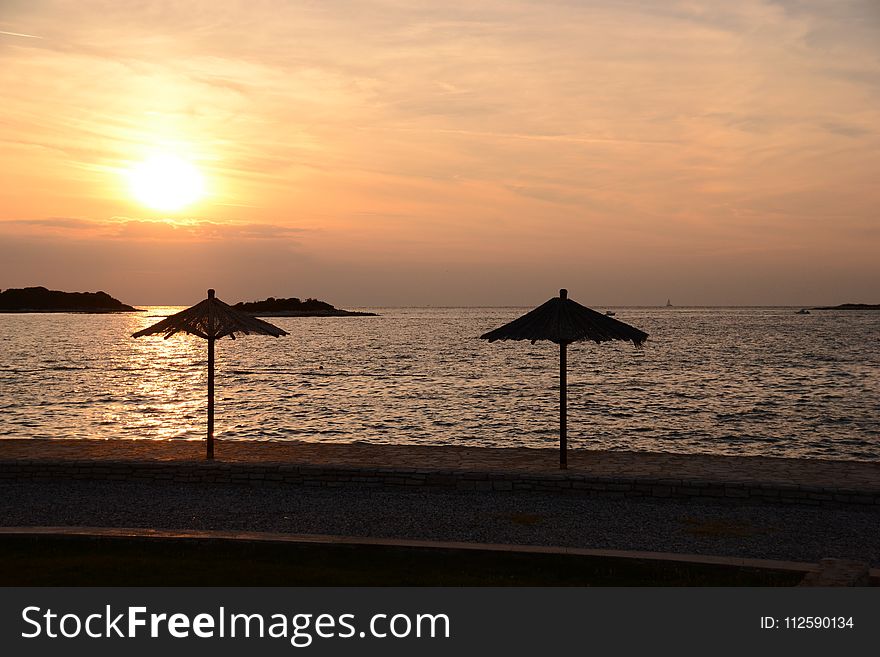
0 459 880 508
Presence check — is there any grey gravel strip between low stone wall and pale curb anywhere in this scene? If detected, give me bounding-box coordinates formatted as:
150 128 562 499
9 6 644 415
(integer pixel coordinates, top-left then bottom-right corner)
0 481 880 567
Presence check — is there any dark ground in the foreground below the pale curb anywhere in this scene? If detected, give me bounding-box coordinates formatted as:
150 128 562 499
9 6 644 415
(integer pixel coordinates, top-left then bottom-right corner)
0 535 804 586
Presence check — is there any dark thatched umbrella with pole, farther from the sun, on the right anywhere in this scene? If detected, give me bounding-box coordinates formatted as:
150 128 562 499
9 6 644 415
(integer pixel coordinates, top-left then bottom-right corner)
480 290 648 468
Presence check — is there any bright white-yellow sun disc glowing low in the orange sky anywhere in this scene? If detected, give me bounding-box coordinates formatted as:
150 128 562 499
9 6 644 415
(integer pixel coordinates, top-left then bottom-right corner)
128 153 205 212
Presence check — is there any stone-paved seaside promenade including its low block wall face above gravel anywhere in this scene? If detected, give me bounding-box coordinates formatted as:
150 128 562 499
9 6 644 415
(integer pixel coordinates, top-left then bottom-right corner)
0 439 880 508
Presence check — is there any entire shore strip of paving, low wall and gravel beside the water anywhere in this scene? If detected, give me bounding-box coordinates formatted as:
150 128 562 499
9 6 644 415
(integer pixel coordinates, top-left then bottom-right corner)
0 440 880 568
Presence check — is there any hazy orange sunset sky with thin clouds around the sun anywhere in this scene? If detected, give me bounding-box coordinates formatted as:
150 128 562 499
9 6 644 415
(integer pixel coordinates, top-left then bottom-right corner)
0 0 880 306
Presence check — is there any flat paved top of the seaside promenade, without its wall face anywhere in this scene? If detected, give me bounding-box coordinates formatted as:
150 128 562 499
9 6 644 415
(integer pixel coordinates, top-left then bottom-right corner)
0 439 880 491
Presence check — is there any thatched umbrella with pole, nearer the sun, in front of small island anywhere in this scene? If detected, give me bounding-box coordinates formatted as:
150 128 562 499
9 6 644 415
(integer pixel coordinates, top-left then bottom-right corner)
131 290 287 459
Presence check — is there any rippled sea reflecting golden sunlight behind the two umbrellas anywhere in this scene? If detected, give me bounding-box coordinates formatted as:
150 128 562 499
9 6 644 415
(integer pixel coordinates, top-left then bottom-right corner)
0 308 880 460
